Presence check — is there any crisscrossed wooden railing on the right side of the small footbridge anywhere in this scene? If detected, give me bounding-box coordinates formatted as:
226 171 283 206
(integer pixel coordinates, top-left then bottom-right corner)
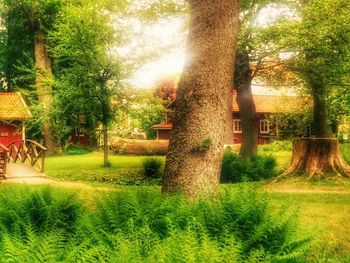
7 140 47 173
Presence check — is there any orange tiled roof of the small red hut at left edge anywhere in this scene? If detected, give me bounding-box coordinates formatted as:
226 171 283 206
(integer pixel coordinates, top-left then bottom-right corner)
0 92 32 121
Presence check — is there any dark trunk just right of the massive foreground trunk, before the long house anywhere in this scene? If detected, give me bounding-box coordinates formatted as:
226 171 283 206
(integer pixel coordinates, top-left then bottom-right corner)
234 50 258 158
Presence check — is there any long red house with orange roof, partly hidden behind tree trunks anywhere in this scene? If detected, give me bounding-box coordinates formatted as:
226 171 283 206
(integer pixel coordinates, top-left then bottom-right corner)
153 93 310 144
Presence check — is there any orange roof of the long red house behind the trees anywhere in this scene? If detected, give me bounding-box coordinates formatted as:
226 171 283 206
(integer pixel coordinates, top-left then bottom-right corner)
232 94 312 113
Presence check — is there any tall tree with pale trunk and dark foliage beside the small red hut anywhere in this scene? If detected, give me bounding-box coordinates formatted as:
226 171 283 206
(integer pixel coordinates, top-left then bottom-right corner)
3 0 63 153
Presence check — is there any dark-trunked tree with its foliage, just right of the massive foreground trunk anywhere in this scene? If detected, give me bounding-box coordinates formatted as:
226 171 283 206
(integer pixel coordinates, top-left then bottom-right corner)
234 0 294 157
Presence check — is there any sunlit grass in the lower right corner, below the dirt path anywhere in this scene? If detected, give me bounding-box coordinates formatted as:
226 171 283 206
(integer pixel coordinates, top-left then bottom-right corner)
268 192 350 262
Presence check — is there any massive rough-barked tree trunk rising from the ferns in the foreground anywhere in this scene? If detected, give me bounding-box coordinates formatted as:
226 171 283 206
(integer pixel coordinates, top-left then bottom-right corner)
162 0 239 198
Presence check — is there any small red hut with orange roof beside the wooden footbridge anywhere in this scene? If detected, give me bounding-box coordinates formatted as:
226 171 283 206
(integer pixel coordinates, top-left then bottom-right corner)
0 92 32 145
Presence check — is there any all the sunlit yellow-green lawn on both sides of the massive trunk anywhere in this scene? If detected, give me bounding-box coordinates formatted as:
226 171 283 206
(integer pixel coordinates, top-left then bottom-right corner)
14 145 350 262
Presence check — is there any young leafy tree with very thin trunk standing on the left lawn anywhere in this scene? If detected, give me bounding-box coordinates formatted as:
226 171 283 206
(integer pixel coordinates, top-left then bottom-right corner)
50 1 125 166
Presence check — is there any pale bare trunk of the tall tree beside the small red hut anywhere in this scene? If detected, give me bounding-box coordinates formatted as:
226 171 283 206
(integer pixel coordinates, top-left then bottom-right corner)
34 27 60 153
